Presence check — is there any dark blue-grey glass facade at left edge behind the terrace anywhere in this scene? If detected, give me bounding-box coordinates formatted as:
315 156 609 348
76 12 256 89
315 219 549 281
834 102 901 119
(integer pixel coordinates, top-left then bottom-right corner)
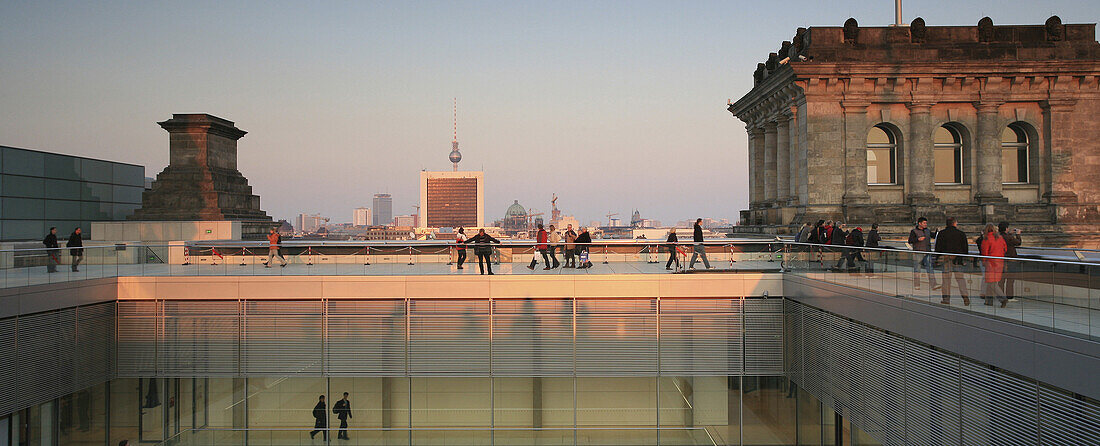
0 146 145 241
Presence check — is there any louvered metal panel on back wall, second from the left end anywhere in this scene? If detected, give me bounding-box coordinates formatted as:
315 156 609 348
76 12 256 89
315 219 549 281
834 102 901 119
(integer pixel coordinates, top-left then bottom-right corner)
157 301 240 377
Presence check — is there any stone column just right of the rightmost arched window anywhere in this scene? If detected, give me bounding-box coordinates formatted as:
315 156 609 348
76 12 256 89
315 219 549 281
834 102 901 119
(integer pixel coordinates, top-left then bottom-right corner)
1029 99 1095 204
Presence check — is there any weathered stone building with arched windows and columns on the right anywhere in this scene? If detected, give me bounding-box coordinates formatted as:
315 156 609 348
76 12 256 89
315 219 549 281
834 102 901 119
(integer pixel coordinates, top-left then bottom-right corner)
728 17 1100 244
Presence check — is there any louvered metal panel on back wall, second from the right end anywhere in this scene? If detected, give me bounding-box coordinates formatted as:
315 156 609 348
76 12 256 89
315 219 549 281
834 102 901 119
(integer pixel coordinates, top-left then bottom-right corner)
660 298 741 376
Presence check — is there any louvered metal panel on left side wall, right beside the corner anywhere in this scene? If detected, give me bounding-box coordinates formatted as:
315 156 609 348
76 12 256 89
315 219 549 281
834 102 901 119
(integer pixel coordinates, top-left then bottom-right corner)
74 302 116 389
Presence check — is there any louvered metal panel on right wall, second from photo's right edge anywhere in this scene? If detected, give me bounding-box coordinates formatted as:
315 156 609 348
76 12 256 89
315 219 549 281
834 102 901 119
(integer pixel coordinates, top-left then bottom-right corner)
961 361 1038 445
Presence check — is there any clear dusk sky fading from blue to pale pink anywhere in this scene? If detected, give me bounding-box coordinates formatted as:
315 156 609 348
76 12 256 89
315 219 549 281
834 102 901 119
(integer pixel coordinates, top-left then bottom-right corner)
0 0 1100 224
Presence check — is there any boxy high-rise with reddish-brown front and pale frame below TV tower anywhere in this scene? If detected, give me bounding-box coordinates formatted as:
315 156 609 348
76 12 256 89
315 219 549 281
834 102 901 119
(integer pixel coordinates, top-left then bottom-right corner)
418 171 485 228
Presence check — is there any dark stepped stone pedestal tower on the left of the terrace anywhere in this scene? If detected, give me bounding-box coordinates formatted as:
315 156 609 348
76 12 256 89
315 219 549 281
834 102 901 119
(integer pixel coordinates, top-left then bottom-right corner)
130 113 275 239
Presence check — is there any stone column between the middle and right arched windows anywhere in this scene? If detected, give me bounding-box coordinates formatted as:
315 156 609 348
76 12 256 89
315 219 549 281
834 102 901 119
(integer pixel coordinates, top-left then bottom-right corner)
975 102 1005 202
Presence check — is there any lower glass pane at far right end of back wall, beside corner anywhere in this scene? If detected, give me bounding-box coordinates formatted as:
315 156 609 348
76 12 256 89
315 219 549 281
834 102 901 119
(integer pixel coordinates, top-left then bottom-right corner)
741 377 796 445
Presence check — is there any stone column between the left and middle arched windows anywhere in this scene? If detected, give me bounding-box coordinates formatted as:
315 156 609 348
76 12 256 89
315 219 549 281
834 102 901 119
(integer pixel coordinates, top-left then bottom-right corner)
899 102 936 205
